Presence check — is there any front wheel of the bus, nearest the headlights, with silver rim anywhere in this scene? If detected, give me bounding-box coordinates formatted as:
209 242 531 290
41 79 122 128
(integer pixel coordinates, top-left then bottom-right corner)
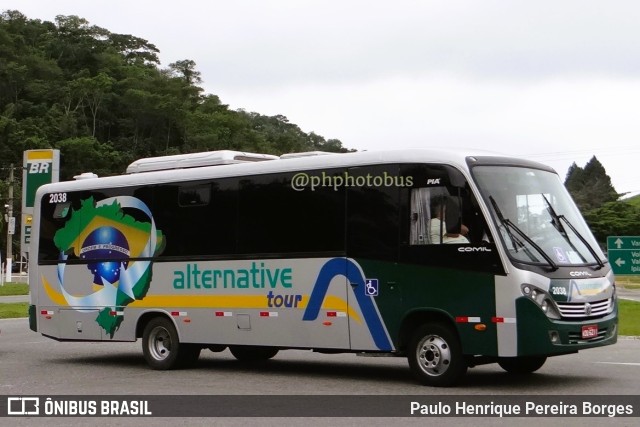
407 323 467 387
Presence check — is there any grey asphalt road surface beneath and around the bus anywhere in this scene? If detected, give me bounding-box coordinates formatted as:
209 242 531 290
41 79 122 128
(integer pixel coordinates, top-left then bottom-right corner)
0 319 640 426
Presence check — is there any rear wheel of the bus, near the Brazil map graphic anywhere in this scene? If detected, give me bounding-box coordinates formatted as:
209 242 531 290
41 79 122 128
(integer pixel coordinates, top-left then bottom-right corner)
142 317 202 370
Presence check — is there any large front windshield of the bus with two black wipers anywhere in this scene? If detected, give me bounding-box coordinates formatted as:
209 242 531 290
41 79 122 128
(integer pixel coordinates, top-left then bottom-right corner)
473 166 604 270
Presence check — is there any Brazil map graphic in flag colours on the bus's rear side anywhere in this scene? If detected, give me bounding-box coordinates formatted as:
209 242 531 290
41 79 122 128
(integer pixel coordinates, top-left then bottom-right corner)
50 196 164 338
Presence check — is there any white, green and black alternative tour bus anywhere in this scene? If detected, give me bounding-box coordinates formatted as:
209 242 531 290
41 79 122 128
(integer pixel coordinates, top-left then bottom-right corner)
29 150 617 386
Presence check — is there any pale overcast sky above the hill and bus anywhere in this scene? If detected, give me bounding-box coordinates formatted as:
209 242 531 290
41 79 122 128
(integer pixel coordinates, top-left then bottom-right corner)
5 0 640 193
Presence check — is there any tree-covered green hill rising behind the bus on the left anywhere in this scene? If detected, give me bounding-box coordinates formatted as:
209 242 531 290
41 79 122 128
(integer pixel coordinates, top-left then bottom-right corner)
0 11 347 179
